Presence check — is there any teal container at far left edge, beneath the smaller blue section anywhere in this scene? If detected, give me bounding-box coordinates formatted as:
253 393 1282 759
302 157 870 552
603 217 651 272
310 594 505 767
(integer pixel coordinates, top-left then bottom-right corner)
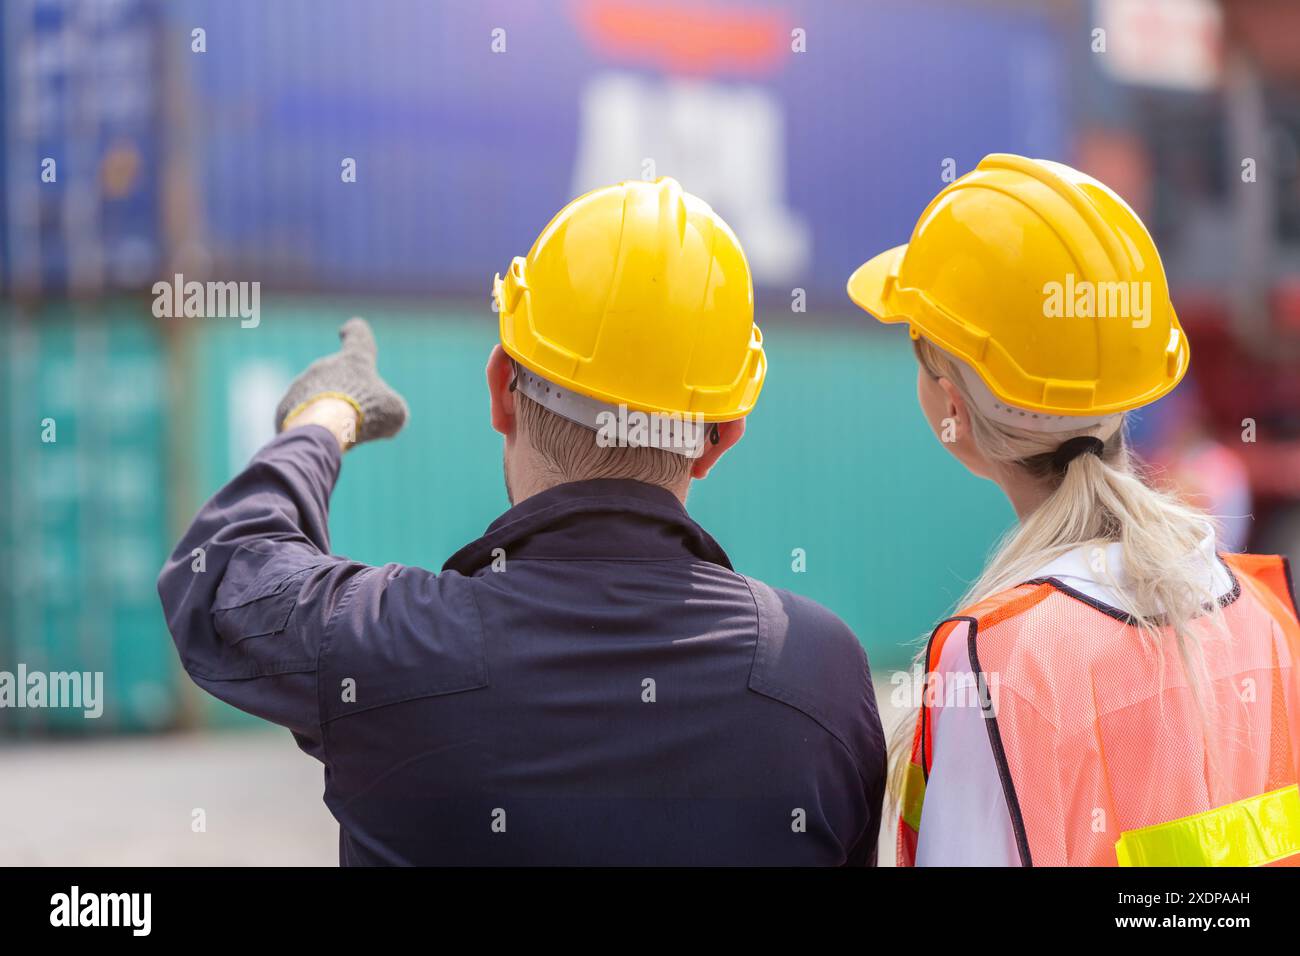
0 302 178 736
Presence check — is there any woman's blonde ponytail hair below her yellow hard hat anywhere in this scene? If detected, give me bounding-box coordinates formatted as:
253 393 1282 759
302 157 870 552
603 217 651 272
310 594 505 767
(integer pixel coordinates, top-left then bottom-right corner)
889 338 1222 801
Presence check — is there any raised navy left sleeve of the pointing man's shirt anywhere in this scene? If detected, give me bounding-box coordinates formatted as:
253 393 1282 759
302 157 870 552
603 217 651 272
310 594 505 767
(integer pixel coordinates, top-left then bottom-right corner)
159 425 368 760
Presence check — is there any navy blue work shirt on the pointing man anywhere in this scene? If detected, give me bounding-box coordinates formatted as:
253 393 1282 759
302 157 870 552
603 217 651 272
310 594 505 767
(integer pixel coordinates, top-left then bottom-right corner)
159 425 885 865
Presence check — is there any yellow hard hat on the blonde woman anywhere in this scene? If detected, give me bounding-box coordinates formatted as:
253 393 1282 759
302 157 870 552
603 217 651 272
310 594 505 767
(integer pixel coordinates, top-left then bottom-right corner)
849 153 1188 416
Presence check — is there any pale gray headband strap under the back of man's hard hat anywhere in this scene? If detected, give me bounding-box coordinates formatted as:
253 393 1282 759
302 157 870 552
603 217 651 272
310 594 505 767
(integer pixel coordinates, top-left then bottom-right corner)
510 362 720 458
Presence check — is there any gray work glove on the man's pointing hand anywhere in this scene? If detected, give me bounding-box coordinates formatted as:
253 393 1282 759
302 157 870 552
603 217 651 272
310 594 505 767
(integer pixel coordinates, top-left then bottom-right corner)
276 319 407 445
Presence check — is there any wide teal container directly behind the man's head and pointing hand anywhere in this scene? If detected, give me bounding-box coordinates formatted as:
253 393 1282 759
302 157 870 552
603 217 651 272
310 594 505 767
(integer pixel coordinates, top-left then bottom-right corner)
183 303 1011 728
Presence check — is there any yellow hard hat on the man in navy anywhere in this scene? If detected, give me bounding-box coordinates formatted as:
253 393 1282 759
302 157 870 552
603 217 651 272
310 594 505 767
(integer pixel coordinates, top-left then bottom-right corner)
493 178 767 421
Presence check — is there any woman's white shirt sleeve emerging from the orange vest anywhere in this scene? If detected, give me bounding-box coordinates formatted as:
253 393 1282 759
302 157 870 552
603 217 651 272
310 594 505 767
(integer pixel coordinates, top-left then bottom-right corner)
917 626 1021 866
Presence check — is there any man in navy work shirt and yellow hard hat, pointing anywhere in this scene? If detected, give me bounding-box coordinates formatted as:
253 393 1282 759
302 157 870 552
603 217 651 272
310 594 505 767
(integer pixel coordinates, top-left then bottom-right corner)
159 179 884 865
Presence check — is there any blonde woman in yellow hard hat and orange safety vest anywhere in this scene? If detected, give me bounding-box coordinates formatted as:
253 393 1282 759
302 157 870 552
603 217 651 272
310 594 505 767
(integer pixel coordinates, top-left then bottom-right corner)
849 155 1300 865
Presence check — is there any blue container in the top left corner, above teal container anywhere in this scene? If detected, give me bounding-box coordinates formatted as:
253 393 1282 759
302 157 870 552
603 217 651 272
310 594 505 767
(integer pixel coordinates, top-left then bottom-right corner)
0 0 165 295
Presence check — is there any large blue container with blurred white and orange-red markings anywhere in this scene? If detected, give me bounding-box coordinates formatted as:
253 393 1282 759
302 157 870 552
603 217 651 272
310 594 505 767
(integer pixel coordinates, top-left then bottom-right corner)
168 0 1069 295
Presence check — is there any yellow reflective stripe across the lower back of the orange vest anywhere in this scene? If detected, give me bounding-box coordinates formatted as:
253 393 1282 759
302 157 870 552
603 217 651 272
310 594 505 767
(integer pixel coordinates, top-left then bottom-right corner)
1115 786 1300 866
